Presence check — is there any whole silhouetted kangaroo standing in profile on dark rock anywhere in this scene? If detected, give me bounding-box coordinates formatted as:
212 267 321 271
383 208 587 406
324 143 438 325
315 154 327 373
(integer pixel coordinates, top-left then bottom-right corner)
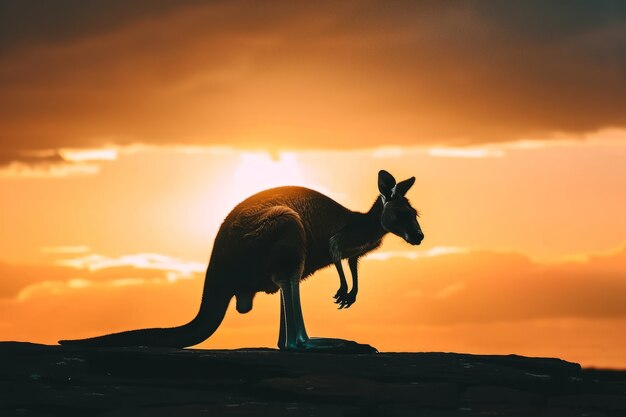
59 170 424 353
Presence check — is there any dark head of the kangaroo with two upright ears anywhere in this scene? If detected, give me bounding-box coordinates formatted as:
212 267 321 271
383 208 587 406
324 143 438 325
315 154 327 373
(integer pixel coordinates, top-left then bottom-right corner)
378 170 424 245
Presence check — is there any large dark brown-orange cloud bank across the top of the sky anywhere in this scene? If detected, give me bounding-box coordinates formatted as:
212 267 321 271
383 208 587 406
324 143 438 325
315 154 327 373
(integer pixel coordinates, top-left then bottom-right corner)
0 0 626 164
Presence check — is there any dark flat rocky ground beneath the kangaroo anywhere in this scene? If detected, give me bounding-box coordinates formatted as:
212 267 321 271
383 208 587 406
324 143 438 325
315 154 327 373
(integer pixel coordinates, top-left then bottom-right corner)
0 342 626 417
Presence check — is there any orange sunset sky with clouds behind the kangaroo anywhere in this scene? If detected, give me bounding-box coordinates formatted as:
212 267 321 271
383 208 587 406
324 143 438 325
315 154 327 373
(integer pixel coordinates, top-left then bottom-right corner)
0 0 626 368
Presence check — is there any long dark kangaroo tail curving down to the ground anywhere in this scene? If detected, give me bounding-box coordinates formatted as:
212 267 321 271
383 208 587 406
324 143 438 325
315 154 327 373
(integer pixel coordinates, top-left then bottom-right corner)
59 267 233 348
